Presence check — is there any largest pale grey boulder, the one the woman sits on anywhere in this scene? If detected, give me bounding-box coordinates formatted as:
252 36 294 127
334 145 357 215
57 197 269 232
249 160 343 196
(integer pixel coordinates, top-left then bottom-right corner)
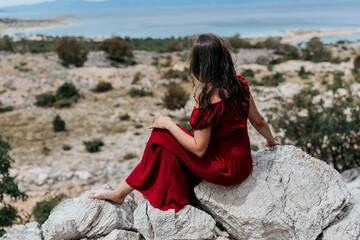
195 146 350 240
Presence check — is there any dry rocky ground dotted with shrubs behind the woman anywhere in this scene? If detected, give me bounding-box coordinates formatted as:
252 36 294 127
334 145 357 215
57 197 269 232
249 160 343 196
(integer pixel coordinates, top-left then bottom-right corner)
0 41 360 227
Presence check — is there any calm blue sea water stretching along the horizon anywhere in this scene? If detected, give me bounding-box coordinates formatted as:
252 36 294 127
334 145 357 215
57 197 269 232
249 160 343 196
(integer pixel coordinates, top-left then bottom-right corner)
0 0 360 42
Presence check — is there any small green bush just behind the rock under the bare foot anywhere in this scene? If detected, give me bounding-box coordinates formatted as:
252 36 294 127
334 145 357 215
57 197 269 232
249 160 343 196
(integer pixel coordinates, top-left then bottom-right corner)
32 195 63 225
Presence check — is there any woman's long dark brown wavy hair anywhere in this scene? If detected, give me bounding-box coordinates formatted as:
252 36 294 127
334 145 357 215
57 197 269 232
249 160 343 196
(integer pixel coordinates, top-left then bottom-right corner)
187 33 245 123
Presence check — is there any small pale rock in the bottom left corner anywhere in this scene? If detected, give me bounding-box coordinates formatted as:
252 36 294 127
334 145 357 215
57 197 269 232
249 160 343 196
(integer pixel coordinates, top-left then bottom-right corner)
0 222 42 240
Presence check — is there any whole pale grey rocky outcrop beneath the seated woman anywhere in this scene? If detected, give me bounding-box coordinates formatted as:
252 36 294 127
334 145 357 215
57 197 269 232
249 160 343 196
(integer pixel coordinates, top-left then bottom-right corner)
0 146 360 240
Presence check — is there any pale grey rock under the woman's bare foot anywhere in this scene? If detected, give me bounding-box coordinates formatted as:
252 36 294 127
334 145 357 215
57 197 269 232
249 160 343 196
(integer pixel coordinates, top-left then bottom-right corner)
42 184 136 240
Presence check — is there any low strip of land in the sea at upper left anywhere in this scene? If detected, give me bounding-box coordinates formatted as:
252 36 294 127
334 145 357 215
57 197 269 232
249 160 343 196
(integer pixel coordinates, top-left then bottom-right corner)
0 15 80 33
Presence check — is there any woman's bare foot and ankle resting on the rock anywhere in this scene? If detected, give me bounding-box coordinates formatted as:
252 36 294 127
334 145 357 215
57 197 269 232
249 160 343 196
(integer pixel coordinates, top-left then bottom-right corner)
89 181 134 203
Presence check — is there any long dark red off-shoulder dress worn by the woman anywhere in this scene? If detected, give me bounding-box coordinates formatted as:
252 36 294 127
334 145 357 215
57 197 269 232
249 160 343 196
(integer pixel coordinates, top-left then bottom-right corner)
125 75 253 212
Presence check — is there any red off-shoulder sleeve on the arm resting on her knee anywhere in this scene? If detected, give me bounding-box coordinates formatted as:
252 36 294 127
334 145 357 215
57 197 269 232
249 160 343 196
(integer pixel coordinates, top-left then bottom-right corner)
189 103 224 129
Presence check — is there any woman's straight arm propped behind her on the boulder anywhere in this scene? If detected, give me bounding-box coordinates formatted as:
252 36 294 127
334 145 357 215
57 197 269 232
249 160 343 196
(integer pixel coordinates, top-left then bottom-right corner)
249 94 279 146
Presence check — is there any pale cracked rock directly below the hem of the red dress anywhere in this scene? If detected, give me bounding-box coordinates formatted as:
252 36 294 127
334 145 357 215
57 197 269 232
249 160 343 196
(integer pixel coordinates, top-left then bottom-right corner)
134 197 215 240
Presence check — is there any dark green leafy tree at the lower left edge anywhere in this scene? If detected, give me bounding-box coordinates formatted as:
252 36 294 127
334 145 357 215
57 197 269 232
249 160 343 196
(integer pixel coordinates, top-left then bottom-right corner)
0 133 27 236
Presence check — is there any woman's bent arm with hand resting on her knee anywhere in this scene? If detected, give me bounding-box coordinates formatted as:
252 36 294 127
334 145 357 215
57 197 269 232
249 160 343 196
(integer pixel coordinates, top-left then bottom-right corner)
148 116 212 158
